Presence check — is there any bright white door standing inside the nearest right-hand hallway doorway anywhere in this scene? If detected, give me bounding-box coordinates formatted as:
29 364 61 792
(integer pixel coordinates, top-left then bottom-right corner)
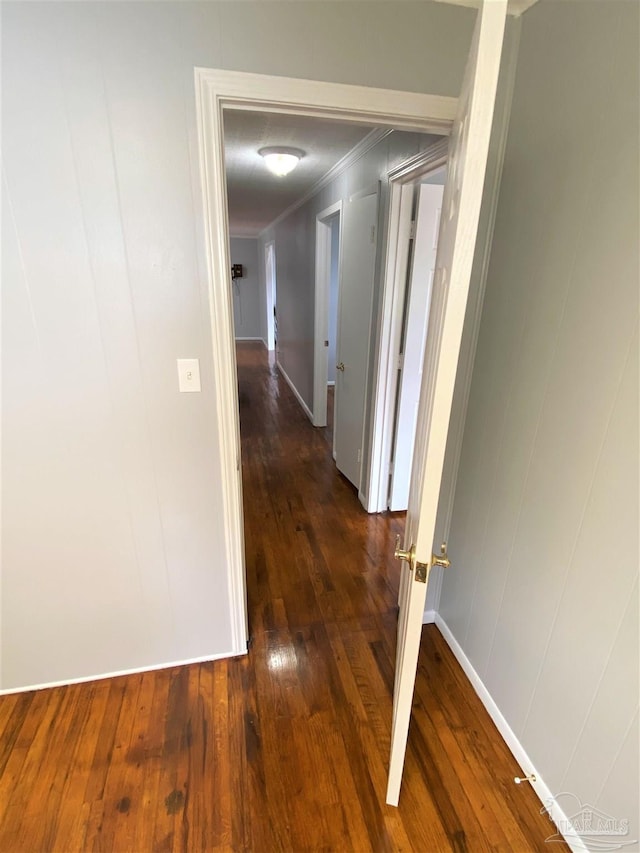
389 184 444 511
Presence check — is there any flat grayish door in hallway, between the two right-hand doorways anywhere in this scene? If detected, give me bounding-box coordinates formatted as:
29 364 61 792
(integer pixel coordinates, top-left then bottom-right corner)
334 187 378 488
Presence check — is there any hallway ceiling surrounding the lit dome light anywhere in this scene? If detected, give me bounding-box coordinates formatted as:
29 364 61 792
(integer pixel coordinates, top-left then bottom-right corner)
224 109 374 237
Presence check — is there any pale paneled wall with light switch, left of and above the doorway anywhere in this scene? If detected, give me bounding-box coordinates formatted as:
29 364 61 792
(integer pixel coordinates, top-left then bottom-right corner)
1 2 474 687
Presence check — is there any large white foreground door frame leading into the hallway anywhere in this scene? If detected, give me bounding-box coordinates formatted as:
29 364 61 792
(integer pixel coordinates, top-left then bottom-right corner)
194 68 458 656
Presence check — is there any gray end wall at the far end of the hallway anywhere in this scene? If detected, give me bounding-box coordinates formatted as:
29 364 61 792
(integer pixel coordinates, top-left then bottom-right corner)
230 237 265 340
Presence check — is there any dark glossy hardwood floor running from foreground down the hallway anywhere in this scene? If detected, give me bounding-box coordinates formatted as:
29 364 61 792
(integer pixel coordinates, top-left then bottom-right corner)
0 344 555 853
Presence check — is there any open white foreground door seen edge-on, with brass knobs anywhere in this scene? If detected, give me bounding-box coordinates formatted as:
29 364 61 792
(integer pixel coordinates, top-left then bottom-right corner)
387 0 507 806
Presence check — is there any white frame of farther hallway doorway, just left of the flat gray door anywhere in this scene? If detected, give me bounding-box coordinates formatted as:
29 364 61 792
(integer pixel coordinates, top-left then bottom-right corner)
313 199 342 427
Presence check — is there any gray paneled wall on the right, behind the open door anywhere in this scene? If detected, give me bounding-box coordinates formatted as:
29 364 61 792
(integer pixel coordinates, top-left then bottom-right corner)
440 2 640 849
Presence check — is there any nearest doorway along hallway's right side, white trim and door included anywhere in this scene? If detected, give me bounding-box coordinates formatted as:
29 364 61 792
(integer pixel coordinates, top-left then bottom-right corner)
366 140 448 512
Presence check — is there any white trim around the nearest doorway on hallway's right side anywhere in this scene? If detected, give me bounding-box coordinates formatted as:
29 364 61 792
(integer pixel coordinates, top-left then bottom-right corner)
364 139 449 512
